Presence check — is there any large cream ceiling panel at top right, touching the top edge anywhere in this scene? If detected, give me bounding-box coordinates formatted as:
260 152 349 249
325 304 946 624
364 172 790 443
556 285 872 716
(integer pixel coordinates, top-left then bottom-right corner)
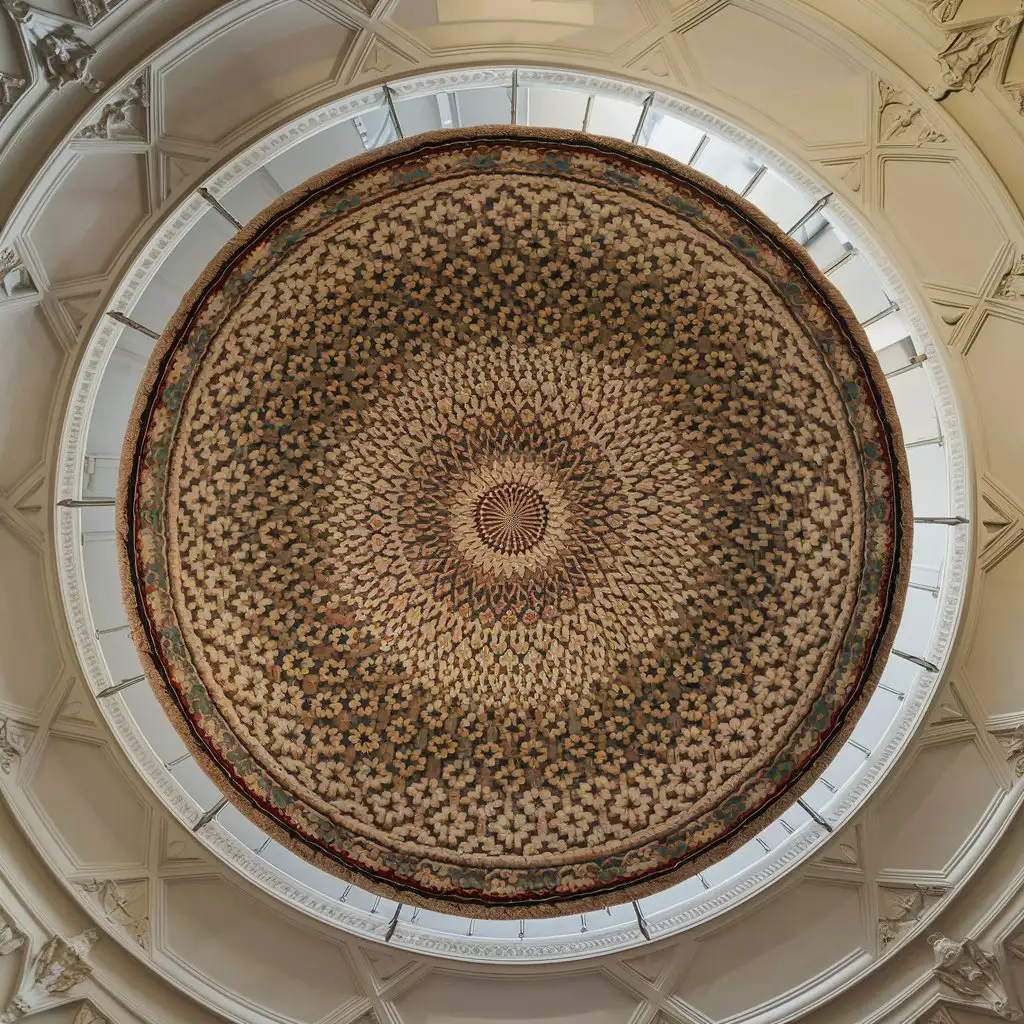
681 4 870 146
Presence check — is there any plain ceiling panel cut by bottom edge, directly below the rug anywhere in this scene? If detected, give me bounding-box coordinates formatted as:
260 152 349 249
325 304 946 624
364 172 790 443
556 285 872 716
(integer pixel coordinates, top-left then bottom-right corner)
395 972 637 1024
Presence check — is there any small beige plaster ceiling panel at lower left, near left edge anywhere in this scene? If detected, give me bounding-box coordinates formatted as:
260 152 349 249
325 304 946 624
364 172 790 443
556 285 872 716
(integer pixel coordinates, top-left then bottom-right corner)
31 734 150 867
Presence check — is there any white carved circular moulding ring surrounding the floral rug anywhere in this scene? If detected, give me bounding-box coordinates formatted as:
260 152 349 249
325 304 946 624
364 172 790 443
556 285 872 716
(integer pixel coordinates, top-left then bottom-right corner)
54 68 972 958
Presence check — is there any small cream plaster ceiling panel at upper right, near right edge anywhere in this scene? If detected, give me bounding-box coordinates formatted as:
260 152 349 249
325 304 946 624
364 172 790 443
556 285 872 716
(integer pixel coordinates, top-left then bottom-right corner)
881 156 1006 290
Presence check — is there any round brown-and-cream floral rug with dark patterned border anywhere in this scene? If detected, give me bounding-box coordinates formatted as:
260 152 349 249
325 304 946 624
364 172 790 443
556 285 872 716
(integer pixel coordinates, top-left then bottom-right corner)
119 128 910 918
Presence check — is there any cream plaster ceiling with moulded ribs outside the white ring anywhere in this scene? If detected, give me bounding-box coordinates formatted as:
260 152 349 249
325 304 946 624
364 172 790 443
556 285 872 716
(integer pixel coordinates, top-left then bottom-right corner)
0 0 1024 1024
